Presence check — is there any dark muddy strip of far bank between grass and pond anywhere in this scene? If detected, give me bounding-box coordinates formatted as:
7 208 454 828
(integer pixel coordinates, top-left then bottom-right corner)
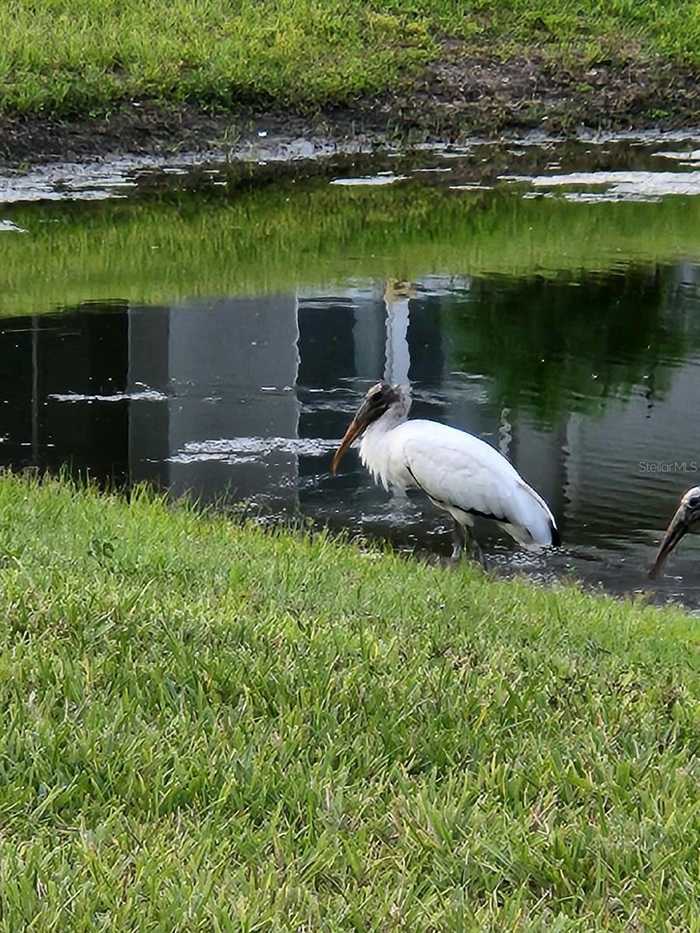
0 51 700 171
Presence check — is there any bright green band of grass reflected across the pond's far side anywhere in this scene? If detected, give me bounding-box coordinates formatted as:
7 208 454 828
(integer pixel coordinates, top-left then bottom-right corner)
0 180 700 315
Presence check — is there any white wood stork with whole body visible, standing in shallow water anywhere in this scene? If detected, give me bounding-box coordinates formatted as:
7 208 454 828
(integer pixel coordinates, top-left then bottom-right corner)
331 382 559 559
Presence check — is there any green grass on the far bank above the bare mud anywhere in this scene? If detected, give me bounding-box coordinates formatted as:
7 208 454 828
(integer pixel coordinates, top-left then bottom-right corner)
0 0 700 114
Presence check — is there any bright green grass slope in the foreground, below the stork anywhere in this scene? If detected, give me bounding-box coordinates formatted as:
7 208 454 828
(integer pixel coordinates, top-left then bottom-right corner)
0 476 700 933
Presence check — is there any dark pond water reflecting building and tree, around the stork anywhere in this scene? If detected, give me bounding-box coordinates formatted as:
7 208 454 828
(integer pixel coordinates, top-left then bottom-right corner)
0 262 700 607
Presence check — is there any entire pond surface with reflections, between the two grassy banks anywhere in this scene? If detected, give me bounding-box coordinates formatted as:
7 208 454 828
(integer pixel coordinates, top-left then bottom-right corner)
0 137 700 608
